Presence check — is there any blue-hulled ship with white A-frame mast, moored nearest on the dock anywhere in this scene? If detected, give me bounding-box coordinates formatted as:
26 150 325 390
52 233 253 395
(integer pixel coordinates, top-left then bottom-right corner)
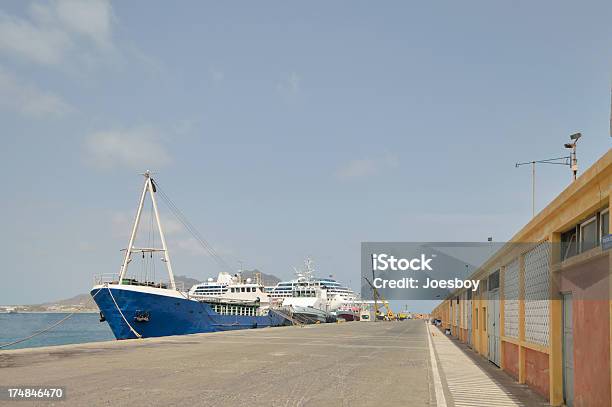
90 171 288 339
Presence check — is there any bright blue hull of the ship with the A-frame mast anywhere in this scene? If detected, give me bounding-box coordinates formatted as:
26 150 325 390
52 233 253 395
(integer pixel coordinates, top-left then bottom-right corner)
91 285 287 339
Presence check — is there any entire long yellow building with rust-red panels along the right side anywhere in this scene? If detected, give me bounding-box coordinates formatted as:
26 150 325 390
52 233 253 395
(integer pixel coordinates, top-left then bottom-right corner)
432 150 612 407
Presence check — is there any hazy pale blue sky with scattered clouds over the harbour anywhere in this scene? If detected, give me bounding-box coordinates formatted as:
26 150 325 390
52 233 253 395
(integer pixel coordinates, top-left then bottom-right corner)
0 0 612 312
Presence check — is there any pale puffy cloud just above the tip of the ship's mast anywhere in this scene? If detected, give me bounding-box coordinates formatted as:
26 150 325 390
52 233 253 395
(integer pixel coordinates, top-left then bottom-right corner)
85 126 171 171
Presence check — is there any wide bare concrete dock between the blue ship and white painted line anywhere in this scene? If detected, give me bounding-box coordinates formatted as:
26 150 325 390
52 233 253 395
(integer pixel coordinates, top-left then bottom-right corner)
0 320 544 406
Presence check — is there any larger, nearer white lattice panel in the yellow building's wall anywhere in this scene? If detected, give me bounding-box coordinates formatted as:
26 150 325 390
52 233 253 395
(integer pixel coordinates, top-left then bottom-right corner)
525 242 550 346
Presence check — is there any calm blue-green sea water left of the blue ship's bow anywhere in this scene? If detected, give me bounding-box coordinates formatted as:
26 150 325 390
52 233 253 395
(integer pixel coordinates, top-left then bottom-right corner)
0 313 115 349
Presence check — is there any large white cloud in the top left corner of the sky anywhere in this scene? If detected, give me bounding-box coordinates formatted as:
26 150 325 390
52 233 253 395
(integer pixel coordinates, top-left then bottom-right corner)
0 0 113 65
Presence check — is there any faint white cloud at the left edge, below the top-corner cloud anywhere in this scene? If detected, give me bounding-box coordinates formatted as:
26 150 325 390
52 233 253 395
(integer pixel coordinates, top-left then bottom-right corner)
0 67 74 118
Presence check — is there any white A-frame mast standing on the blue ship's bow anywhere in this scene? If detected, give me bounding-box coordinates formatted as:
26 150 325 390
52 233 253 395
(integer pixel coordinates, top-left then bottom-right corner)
119 171 176 290
